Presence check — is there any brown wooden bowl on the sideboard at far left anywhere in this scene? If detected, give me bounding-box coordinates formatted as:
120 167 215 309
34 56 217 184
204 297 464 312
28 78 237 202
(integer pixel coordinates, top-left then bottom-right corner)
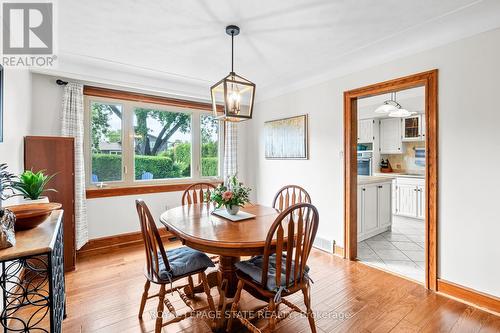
5 202 62 231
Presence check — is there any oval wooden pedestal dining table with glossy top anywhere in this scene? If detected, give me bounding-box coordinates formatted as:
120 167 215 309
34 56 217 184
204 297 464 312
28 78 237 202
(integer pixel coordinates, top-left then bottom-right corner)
160 203 279 297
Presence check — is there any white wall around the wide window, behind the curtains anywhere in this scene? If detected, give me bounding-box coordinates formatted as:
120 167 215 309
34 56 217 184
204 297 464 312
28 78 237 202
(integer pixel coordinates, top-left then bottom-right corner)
28 73 247 239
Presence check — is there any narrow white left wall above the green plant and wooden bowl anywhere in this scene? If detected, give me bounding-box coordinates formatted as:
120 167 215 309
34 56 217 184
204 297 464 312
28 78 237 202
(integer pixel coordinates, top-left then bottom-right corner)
0 68 31 205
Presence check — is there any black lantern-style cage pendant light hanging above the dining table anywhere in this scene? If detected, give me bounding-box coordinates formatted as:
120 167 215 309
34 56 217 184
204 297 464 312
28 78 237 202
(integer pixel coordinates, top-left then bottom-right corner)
210 25 255 122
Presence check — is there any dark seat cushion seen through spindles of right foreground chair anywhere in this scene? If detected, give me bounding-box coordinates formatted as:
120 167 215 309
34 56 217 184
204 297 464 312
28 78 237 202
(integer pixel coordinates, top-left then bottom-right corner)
235 253 309 291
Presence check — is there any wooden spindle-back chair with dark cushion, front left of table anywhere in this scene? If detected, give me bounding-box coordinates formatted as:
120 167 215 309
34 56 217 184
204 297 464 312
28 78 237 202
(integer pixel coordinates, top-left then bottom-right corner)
135 200 215 333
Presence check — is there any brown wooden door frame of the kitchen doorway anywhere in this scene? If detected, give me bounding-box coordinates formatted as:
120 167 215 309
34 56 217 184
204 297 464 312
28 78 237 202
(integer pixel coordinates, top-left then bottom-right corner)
344 70 438 290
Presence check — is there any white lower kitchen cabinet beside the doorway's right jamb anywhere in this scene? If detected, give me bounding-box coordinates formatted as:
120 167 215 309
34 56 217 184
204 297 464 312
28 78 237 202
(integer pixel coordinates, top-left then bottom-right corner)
393 177 425 219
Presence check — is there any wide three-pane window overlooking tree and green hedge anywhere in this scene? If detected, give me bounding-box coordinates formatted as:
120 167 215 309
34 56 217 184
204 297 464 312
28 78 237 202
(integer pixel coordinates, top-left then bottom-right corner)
85 91 223 187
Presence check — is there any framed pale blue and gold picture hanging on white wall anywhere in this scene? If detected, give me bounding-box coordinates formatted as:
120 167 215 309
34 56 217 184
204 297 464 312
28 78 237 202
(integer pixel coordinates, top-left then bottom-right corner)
264 115 309 160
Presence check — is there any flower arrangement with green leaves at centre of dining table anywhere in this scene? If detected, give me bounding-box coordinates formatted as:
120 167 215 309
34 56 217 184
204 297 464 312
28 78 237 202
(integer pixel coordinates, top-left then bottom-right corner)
209 176 251 215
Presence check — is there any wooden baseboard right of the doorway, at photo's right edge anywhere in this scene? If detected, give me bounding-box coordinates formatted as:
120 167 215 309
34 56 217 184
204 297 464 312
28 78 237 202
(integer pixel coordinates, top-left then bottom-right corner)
437 279 500 315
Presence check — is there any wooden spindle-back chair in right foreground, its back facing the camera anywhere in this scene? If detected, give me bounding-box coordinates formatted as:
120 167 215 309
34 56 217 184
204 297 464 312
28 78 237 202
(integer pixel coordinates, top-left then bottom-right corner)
227 203 319 332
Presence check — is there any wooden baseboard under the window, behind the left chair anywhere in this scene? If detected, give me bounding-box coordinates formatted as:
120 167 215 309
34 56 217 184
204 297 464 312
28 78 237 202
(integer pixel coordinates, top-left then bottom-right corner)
76 228 175 258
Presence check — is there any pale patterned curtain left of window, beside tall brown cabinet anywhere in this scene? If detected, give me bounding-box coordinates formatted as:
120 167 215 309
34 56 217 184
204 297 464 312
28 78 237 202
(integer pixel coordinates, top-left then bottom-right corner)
62 83 89 250
